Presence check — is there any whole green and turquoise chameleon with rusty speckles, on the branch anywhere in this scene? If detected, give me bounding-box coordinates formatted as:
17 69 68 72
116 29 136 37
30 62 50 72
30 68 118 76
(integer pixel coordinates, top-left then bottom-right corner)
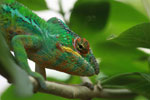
0 0 99 87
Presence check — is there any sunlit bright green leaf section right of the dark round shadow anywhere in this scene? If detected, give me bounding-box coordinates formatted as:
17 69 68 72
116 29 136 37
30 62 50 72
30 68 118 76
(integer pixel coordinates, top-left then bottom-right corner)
106 0 149 35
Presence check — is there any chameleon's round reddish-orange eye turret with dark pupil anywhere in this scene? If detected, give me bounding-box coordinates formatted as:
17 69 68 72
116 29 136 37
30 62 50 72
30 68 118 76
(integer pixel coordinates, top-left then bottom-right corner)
74 38 89 54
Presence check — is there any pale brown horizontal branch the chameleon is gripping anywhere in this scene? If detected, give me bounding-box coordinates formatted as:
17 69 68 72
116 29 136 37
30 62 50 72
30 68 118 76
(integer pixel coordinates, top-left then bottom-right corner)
30 77 136 99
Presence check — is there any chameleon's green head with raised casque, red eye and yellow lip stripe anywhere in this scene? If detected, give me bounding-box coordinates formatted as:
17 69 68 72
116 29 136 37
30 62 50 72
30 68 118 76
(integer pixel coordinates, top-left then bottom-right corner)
48 17 99 76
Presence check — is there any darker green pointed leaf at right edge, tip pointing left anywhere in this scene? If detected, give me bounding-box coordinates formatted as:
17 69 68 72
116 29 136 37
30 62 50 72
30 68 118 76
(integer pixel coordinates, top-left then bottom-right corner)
113 23 150 48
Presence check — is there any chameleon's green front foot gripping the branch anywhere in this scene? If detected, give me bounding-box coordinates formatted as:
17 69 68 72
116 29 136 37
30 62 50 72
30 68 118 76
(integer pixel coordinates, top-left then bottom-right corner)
30 72 47 90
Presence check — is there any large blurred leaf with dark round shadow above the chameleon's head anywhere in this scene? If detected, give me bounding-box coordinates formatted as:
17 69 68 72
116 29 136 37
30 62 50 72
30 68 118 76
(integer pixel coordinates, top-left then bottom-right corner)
70 0 149 43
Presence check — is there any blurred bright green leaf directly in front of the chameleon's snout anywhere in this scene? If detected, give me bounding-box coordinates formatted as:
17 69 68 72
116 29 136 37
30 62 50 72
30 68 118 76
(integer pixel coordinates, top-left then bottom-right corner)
93 42 149 75
